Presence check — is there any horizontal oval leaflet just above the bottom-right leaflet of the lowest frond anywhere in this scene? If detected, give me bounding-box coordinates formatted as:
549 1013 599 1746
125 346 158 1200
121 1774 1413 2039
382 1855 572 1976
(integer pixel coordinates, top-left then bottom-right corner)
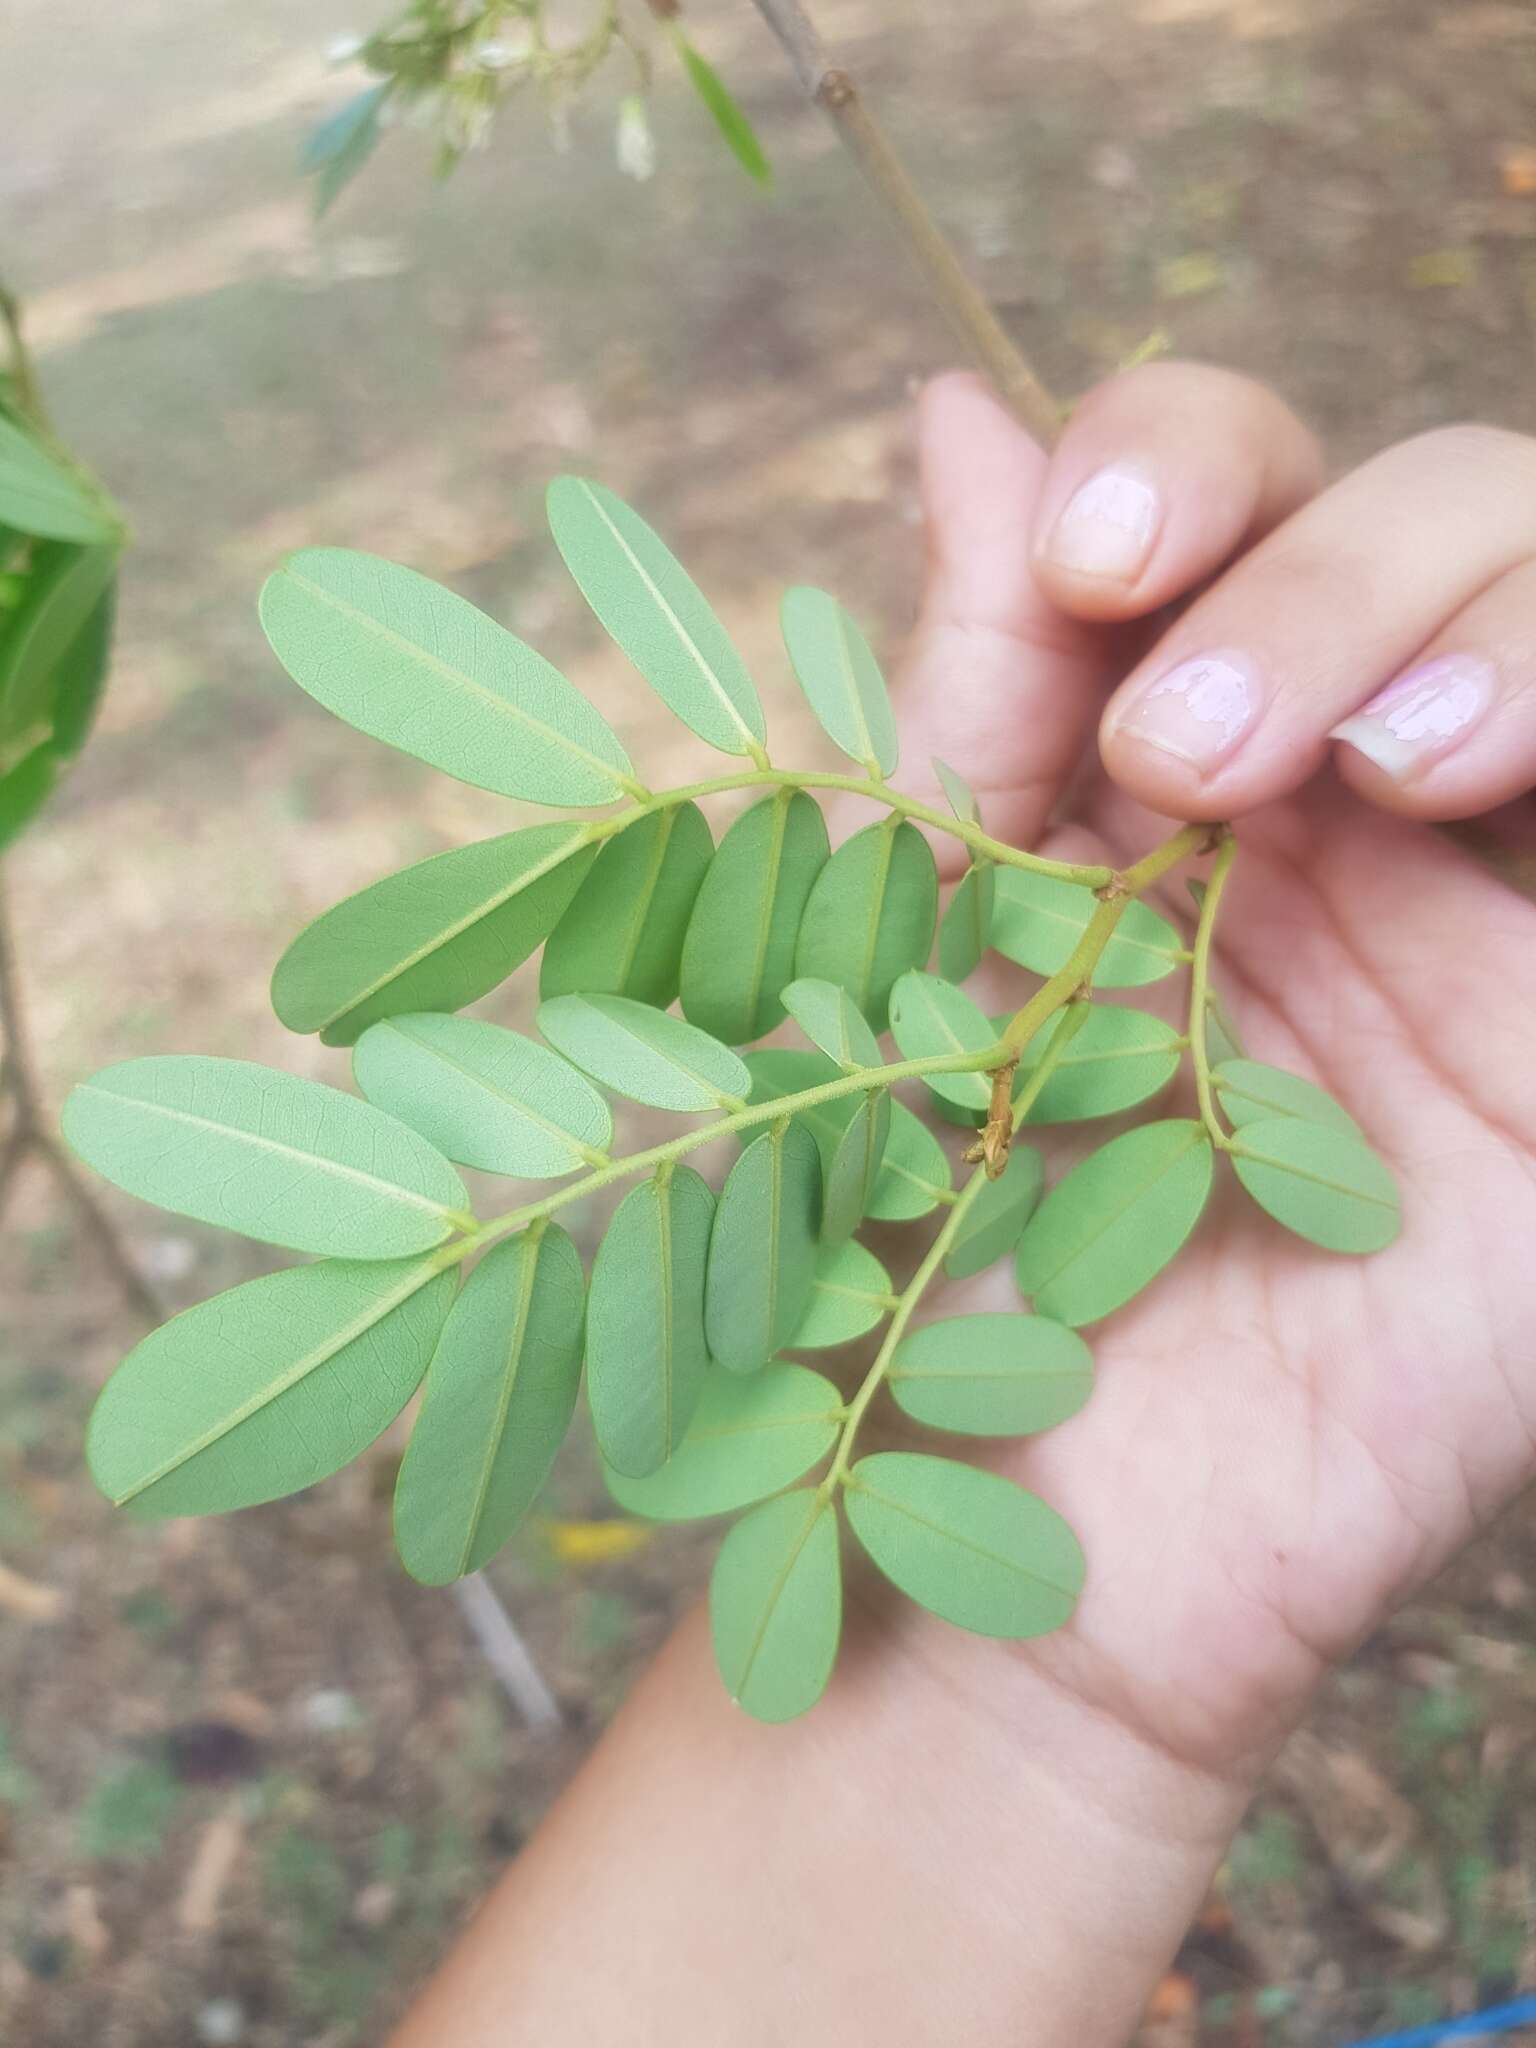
889 1313 1094 1436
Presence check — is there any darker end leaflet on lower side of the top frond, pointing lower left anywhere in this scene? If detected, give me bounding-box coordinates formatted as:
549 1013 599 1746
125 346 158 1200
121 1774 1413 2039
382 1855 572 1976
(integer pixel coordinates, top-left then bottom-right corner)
272 825 596 1044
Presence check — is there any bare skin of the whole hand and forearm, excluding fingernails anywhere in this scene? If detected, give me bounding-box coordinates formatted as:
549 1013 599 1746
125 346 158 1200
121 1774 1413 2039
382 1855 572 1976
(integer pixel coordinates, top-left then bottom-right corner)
395 365 1536 2048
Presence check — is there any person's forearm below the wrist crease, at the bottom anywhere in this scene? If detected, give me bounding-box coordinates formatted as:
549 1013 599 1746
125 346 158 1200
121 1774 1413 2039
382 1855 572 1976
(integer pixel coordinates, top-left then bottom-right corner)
393 1614 1257 2048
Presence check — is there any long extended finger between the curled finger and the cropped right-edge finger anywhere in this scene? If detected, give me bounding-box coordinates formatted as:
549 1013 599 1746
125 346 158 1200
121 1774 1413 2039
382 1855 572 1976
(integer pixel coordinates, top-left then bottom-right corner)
1100 428 1536 819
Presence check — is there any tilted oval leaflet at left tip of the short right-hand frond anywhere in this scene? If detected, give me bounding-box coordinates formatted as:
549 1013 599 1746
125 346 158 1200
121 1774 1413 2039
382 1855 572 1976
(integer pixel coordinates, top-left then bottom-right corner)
1018 1118 1210 1327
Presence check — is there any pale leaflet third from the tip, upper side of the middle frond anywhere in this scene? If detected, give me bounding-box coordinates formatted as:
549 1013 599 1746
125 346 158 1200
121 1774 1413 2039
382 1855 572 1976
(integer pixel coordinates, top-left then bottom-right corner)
539 995 752 1112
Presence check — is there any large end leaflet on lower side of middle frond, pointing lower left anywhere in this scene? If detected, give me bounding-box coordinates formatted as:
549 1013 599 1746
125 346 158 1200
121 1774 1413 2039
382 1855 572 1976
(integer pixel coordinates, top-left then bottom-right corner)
86 1257 459 1516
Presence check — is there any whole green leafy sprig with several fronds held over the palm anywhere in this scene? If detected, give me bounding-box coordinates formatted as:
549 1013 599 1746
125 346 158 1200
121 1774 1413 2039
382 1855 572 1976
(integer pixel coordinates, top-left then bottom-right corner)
66 477 1399 1720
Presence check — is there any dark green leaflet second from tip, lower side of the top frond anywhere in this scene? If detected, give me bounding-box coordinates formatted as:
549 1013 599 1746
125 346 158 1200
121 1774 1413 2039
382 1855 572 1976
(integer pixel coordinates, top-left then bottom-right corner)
539 803 715 1010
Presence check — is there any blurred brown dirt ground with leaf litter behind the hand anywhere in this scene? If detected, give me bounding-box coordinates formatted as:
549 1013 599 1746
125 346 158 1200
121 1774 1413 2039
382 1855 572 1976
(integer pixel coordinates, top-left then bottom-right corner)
0 0 1536 2048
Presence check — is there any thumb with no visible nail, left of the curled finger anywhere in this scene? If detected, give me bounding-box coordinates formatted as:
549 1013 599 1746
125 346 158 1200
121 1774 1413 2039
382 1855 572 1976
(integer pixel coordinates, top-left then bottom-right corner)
899 373 1114 877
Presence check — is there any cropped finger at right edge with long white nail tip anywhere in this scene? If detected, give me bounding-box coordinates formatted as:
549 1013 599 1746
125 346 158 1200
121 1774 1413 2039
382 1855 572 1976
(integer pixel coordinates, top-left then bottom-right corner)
1333 561 1536 821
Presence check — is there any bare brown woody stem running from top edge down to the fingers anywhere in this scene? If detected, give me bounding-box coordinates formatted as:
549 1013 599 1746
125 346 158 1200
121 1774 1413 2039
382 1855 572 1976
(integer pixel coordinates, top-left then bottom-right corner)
741 0 1063 449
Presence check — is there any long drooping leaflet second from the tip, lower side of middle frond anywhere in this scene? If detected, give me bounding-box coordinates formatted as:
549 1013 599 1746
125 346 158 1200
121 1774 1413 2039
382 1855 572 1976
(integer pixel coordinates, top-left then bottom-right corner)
395 1225 586 1585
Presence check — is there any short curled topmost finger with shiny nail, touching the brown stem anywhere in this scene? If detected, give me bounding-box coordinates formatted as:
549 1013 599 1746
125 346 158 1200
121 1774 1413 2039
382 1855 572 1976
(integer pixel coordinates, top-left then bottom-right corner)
1034 362 1323 618
